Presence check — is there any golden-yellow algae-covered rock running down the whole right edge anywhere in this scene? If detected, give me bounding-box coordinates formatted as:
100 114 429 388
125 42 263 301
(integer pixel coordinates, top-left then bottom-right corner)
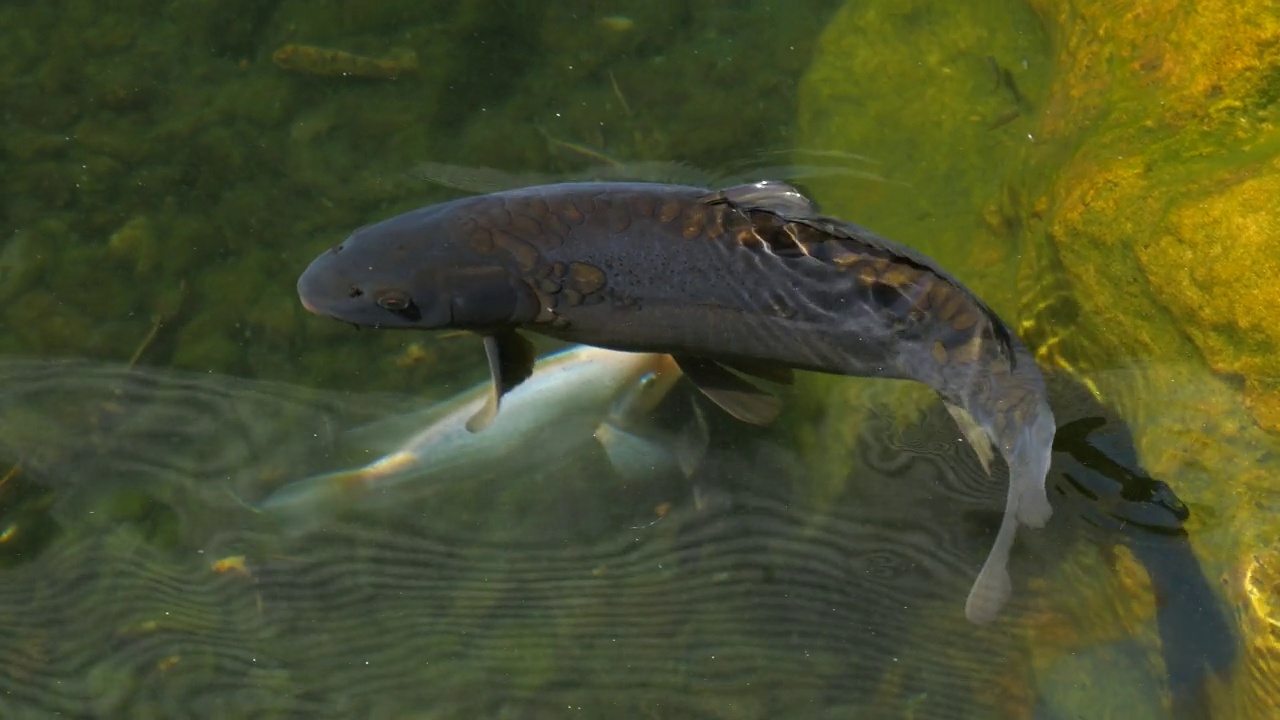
1012 1 1280 717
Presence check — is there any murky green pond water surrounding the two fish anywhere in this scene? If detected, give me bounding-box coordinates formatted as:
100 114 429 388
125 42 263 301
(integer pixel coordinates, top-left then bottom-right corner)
0 0 1280 719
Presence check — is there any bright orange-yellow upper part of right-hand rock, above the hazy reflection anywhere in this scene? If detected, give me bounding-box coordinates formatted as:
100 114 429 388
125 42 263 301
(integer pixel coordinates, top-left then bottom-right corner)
1024 1 1280 430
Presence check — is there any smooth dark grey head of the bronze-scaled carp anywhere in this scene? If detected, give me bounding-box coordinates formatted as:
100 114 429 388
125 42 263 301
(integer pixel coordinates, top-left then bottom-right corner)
298 197 540 331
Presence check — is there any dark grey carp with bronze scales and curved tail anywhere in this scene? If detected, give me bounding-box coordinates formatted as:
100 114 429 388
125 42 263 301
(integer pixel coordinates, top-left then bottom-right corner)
298 182 1055 621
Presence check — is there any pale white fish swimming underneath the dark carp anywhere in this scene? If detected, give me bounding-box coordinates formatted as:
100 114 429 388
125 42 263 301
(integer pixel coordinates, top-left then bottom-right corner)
260 347 699 525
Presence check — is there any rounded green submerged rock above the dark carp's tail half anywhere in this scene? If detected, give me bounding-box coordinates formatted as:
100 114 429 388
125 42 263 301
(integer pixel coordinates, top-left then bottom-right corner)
796 0 1050 297
